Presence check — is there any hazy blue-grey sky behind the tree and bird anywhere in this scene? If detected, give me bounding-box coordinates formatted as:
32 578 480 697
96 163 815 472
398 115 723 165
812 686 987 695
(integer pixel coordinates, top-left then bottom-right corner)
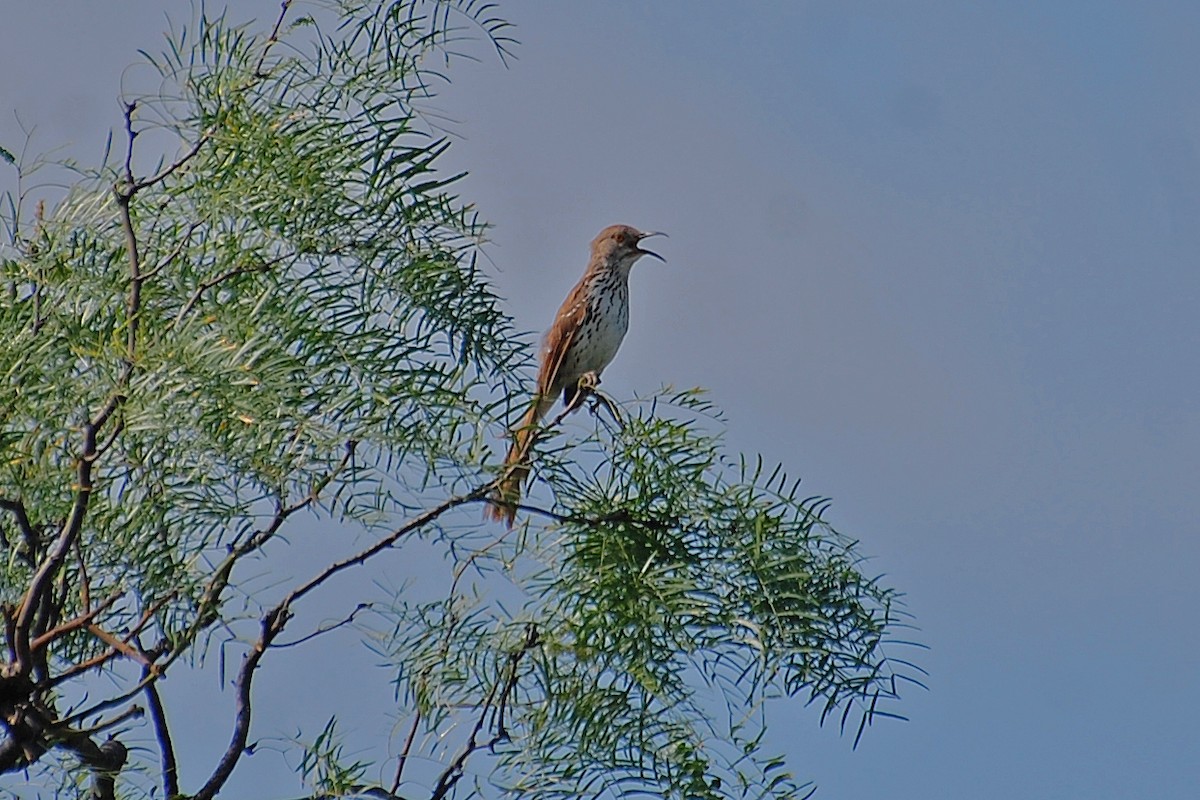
0 0 1200 800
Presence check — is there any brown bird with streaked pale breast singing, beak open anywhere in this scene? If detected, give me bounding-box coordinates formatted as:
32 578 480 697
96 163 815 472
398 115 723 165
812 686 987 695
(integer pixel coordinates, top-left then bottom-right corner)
486 225 666 528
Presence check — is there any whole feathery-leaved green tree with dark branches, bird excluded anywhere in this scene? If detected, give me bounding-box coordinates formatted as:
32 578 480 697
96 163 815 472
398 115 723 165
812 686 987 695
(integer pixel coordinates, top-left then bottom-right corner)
0 0 919 798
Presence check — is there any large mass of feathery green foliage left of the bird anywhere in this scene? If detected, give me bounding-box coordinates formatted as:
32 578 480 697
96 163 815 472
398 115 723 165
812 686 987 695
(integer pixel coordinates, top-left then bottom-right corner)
0 4 524 631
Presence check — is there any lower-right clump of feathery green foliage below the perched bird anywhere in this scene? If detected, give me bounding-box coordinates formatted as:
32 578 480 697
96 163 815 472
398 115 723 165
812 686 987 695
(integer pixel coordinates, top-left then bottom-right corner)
369 392 919 798
